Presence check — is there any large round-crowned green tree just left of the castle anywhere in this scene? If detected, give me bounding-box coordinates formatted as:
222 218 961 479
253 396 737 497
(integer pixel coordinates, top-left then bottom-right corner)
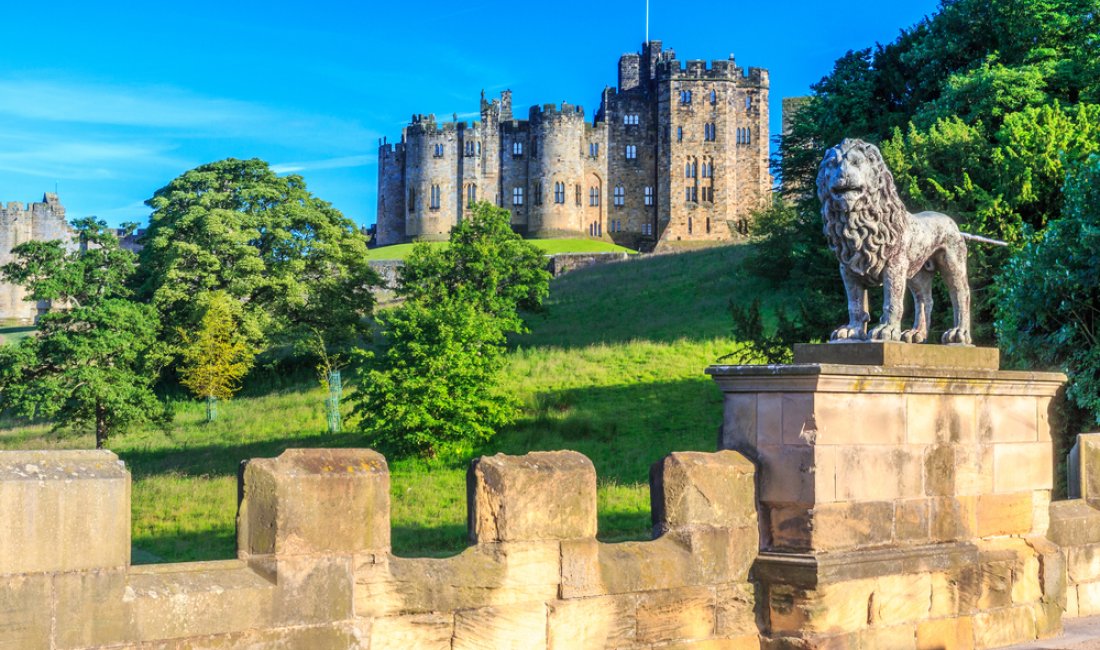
140 158 377 360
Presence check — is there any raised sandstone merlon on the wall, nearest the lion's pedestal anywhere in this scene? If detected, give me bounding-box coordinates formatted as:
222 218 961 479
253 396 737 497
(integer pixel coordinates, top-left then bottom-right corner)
649 451 756 531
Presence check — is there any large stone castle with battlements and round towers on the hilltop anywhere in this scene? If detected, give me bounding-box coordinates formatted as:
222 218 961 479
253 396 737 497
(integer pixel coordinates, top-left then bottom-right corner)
376 41 772 250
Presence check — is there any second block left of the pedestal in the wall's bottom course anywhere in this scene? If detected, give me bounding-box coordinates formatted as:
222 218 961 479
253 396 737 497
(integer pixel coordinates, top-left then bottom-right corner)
637 587 716 643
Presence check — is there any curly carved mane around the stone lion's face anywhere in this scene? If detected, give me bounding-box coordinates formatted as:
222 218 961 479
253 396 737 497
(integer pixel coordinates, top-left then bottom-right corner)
817 140 909 283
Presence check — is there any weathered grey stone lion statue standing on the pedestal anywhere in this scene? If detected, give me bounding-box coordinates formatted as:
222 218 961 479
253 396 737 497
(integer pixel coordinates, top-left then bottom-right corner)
817 140 970 345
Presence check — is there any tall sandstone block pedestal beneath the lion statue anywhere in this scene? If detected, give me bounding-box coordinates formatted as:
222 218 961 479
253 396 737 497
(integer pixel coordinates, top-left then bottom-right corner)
707 343 1065 648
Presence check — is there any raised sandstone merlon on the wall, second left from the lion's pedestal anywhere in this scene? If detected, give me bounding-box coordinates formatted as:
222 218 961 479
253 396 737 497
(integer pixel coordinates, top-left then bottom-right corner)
468 451 596 542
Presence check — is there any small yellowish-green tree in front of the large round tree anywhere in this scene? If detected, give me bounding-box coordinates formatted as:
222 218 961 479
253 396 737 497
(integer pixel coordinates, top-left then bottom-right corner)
179 291 256 422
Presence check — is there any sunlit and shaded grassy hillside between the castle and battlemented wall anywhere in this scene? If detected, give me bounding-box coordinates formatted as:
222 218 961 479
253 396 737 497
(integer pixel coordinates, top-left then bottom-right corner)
0 246 774 561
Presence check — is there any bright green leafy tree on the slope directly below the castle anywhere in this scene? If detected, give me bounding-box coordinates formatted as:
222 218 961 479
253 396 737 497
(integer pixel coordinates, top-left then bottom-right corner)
352 203 550 459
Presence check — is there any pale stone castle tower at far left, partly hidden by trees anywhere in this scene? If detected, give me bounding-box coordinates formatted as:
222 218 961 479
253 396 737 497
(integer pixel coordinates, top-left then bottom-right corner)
0 194 73 322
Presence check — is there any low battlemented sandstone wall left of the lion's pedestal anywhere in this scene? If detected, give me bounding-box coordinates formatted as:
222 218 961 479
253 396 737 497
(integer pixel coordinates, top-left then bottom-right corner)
0 450 758 650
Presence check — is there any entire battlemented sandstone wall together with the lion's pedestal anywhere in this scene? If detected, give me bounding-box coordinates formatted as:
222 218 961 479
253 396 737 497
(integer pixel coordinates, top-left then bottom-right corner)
0 343 1100 650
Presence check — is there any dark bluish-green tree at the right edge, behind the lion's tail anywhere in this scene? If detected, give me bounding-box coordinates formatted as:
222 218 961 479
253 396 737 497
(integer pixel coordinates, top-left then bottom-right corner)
997 157 1100 423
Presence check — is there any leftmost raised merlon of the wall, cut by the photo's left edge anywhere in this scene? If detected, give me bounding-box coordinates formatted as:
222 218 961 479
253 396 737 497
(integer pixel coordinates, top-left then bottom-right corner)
0 451 130 575
